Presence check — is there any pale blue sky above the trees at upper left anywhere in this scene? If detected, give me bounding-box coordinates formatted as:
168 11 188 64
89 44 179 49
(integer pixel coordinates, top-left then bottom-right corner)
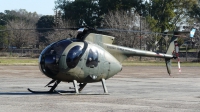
0 0 56 15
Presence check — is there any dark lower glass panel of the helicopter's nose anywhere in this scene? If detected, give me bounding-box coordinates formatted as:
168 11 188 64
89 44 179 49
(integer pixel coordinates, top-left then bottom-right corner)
39 55 59 78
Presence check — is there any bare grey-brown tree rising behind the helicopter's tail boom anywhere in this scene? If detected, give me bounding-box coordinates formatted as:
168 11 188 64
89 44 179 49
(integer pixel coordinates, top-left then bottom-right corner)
103 11 148 48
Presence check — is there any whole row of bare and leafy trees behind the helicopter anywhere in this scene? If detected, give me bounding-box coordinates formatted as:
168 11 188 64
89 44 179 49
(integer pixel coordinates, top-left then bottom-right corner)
0 0 200 50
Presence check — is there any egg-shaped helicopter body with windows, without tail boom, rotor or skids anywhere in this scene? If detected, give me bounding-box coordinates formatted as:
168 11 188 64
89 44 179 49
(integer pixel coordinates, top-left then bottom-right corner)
39 39 122 83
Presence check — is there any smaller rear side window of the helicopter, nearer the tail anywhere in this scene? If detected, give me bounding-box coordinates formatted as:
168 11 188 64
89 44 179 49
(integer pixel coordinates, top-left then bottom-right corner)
86 49 98 68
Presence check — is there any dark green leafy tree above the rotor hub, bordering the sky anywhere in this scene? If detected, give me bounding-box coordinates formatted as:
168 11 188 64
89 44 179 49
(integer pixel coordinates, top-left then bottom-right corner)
56 0 102 27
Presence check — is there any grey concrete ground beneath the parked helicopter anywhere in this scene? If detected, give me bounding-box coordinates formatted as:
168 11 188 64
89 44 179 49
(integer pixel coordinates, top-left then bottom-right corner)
0 66 200 112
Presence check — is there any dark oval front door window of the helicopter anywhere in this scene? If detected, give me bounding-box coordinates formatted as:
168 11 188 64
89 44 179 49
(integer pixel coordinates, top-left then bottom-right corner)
66 46 83 68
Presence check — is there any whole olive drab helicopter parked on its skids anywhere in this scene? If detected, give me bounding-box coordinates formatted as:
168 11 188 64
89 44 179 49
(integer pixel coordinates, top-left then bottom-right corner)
0 27 195 94
